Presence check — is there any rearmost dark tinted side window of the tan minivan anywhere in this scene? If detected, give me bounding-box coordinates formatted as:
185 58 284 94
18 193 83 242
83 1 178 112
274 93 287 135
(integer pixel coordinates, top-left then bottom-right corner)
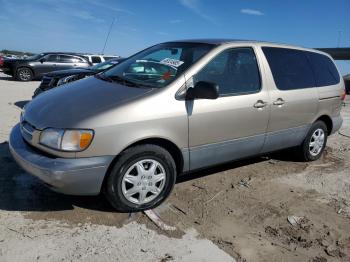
305 52 340 86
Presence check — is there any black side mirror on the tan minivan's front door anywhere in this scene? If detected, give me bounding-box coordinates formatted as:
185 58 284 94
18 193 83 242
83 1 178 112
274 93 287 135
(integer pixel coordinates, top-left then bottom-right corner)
186 81 219 100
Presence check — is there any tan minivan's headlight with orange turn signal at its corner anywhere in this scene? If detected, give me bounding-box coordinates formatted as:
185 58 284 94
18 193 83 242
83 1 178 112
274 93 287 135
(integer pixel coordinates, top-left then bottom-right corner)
39 128 94 152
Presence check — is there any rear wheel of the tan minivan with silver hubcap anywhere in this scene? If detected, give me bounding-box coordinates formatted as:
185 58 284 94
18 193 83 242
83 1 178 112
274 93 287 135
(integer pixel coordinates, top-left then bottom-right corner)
300 121 328 161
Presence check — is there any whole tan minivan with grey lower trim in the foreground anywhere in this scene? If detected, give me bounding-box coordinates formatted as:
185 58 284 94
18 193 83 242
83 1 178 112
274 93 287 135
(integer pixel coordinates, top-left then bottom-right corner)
9 40 345 212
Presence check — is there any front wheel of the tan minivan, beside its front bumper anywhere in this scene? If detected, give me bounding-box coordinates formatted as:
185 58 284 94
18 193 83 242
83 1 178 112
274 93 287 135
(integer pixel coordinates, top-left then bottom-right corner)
104 145 176 212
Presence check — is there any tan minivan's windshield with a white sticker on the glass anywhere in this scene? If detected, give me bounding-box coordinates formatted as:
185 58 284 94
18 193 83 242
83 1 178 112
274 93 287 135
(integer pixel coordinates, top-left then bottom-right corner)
103 42 214 88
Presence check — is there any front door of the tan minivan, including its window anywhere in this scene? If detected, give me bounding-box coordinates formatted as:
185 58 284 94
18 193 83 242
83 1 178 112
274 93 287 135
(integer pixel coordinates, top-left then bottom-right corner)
186 47 269 170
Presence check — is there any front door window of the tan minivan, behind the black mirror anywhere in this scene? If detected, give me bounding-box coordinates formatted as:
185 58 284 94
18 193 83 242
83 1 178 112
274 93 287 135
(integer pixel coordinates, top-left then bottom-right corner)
194 48 261 96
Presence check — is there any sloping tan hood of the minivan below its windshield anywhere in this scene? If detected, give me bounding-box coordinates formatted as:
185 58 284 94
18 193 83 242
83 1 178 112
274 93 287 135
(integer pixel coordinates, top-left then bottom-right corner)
24 77 154 129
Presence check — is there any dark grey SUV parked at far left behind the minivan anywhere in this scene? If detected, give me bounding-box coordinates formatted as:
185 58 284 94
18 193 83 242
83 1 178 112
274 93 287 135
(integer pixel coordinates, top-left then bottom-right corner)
2 53 91 81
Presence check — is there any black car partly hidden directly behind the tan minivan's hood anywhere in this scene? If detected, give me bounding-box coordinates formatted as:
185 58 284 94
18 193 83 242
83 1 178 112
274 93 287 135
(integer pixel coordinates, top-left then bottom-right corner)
33 58 125 98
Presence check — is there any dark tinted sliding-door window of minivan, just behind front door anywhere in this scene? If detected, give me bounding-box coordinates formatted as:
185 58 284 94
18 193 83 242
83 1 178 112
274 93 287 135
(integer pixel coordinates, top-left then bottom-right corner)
262 47 316 90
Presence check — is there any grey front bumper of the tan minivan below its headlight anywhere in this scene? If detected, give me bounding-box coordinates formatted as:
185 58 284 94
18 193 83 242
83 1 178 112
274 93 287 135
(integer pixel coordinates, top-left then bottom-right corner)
9 124 113 195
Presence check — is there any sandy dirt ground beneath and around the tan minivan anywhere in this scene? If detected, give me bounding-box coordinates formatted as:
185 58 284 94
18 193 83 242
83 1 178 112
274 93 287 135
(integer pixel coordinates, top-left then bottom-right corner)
0 72 350 262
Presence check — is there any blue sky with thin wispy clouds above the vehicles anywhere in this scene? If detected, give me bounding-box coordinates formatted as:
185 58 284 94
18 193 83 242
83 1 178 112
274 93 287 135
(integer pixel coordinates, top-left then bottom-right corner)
0 0 350 74
